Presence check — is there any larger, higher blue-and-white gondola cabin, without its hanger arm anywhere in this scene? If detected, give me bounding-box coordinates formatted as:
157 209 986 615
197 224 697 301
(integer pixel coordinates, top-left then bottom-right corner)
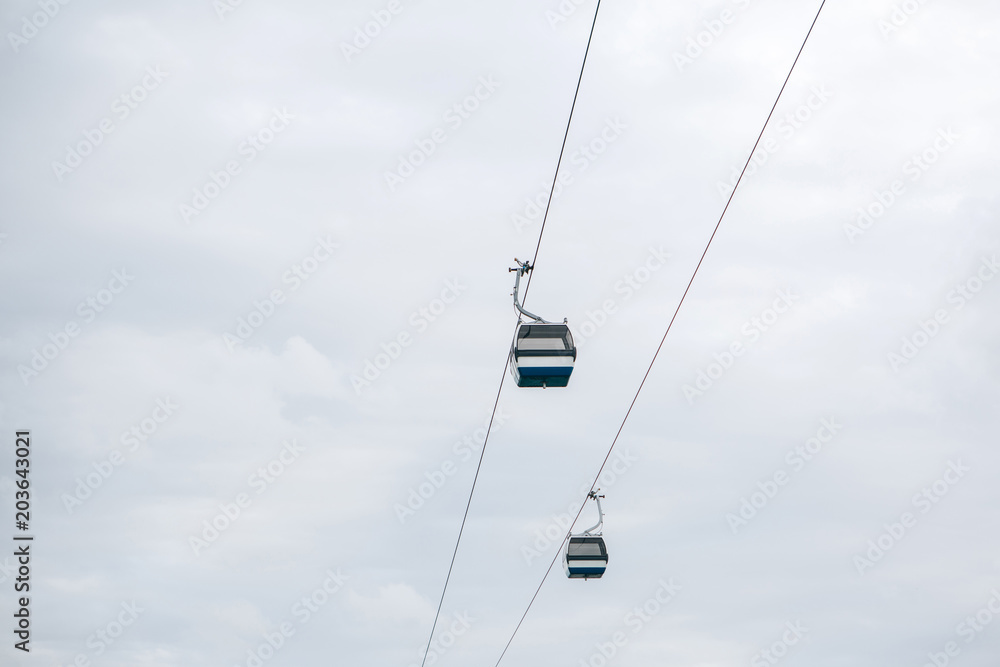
510 322 576 387
